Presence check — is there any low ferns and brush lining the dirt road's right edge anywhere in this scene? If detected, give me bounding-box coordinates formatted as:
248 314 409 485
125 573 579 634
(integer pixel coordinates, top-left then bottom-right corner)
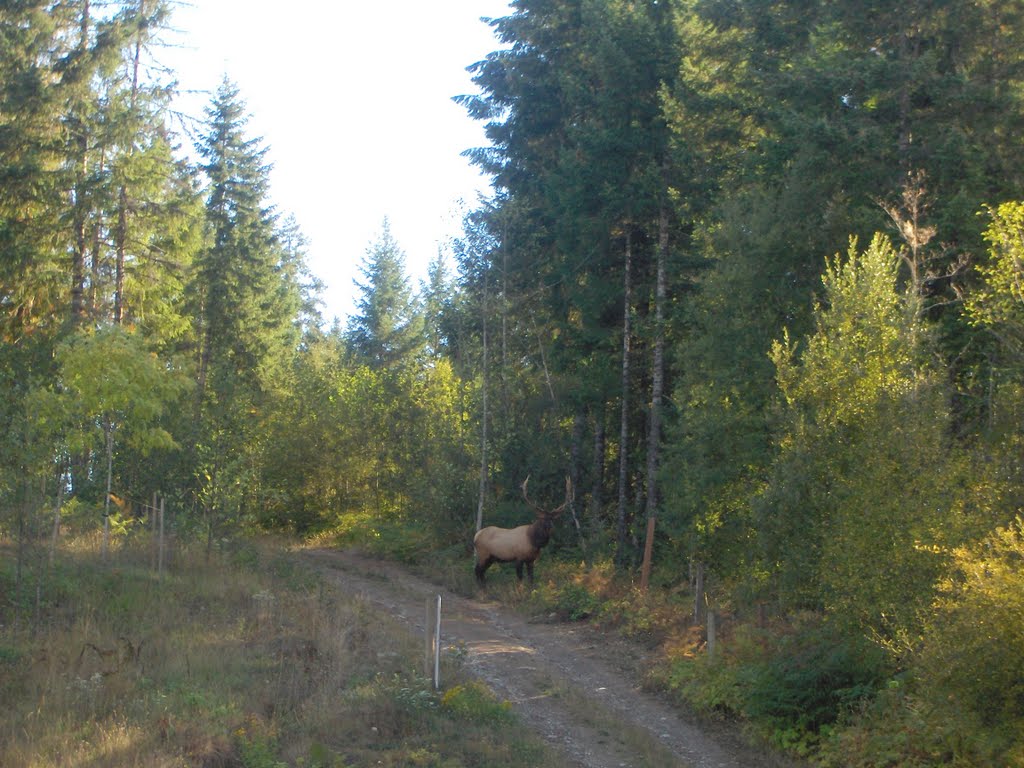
326 523 1024 768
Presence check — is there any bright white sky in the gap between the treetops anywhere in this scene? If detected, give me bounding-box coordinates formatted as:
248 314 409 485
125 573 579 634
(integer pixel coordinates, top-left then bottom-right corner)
158 0 510 321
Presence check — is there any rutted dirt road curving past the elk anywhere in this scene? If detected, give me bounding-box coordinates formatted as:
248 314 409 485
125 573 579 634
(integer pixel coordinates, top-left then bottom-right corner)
304 549 787 768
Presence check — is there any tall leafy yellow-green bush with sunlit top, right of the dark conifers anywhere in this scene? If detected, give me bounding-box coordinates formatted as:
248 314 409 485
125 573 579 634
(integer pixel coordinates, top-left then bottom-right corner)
759 236 958 636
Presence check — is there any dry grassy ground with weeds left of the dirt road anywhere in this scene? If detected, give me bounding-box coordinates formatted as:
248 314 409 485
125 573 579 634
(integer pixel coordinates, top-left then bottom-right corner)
0 542 562 768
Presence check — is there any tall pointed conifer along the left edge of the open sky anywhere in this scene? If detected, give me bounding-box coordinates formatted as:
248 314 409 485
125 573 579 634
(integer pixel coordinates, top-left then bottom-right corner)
191 80 301 542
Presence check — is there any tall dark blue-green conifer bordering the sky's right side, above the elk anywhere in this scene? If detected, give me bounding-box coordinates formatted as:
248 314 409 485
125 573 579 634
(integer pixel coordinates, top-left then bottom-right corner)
461 0 688 562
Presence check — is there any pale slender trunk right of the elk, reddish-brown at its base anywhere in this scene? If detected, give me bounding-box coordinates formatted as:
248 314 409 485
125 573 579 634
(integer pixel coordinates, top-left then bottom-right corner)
640 200 669 591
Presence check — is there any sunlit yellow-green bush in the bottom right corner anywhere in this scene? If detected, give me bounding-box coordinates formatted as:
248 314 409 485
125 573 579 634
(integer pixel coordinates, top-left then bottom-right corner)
822 518 1024 767
